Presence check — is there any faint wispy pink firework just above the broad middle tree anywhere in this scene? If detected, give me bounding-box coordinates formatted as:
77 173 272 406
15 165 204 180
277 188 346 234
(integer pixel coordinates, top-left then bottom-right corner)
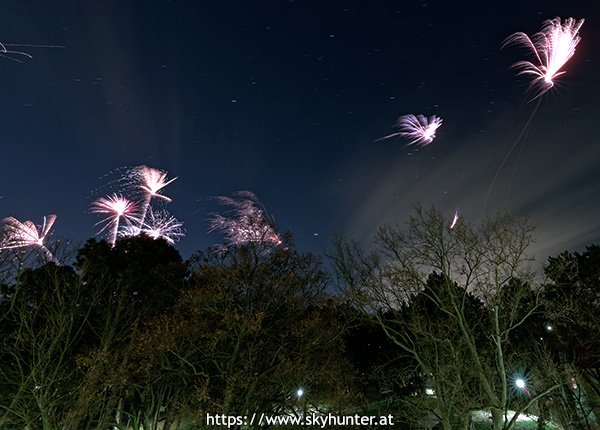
209 191 281 248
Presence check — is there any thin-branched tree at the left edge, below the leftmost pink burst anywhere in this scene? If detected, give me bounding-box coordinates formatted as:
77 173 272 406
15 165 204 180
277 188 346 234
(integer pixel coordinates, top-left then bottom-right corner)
0 263 91 430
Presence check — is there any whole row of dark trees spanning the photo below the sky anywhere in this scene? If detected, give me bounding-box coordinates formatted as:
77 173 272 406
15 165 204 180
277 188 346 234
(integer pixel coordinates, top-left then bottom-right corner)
0 208 600 430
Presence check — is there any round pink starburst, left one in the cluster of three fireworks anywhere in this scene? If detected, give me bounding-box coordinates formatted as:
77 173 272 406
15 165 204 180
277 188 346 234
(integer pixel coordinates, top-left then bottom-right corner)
90 194 139 247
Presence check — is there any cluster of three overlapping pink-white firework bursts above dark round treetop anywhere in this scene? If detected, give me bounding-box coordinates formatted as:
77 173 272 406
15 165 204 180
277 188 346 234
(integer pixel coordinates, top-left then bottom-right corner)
90 166 184 247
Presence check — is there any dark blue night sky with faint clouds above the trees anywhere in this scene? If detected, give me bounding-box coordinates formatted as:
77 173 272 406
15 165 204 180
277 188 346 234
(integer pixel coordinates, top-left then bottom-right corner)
0 0 600 259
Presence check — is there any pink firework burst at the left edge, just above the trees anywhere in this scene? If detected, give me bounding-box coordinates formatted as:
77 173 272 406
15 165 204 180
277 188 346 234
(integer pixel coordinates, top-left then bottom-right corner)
0 215 56 262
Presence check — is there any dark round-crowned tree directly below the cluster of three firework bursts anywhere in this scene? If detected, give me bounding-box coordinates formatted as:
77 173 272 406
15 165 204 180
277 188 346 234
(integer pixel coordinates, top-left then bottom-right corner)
71 235 187 428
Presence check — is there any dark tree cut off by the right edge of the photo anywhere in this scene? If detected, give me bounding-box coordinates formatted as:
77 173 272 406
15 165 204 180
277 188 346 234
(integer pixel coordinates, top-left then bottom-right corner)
543 245 600 429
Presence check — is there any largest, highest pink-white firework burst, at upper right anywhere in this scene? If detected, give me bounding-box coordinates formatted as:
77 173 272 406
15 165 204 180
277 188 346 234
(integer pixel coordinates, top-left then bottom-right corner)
502 17 584 97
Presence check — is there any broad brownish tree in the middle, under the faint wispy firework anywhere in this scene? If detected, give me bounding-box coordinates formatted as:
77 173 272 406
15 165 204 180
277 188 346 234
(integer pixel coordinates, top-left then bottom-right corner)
132 244 350 422
